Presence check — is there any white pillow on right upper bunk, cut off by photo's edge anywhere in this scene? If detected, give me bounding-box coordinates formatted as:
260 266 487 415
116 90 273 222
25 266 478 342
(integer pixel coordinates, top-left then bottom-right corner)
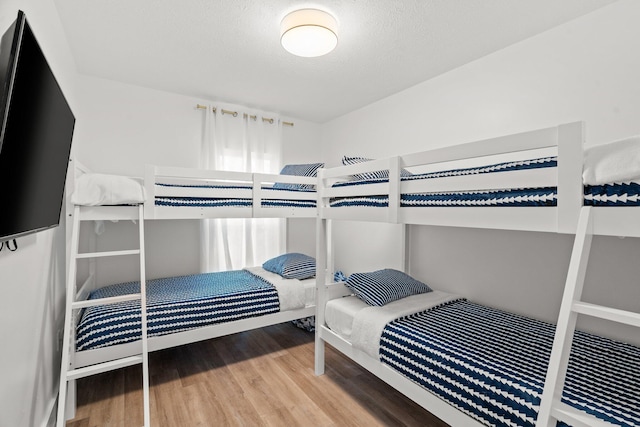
582 135 640 185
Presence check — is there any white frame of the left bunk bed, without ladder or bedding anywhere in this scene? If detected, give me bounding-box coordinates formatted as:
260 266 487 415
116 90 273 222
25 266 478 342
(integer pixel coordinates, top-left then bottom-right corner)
66 158 317 424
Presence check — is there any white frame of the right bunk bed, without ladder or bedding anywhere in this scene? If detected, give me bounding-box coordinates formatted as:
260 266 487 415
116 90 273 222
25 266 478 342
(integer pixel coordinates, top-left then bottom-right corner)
315 122 600 426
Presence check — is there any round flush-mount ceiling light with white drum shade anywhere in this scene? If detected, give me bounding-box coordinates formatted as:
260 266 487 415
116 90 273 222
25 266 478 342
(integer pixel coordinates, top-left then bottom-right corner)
280 9 338 58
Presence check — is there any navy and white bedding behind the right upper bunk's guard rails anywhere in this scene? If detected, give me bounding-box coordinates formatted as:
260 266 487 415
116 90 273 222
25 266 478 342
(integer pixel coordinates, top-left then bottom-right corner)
330 157 558 207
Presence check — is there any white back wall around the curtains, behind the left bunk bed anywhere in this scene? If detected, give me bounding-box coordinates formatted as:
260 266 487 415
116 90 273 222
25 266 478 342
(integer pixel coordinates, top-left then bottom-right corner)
75 76 321 284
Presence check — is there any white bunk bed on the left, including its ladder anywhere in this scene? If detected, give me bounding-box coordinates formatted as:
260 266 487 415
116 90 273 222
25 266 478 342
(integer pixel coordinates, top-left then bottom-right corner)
58 159 317 425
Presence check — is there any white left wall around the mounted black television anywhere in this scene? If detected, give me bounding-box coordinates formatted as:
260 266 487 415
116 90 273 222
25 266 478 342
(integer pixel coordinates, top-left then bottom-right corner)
0 0 80 427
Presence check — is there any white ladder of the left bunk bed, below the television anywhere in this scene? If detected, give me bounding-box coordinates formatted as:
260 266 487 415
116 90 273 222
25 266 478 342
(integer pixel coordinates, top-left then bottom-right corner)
56 205 150 427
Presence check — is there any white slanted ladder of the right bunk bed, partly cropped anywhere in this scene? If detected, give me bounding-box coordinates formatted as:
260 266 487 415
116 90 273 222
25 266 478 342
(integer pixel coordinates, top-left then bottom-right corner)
536 206 640 427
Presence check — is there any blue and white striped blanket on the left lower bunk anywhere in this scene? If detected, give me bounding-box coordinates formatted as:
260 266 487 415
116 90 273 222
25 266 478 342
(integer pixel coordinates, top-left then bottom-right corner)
76 270 280 351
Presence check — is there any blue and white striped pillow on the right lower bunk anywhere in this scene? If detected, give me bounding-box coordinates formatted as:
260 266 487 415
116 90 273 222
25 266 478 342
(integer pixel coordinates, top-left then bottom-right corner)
345 268 431 307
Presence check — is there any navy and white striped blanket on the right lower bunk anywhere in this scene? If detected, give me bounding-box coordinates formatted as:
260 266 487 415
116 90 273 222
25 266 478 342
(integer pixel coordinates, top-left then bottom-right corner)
380 300 640 426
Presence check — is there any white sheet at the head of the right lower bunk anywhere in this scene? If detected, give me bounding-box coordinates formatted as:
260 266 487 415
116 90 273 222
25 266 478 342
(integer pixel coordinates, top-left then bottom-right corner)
325 291 460 359
